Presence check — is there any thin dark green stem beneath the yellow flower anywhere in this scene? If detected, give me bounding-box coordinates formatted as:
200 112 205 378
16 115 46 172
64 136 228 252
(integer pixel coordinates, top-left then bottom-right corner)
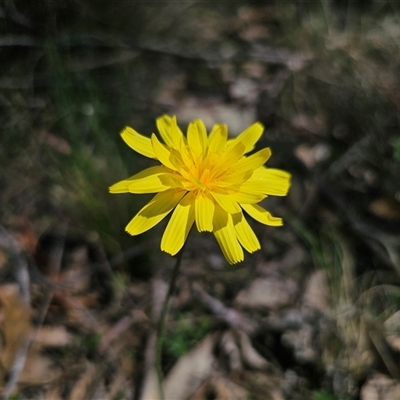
154 248 183 400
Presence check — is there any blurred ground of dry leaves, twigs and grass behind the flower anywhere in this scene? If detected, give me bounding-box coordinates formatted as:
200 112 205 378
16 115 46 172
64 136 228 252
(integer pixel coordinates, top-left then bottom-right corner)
0 0 400 400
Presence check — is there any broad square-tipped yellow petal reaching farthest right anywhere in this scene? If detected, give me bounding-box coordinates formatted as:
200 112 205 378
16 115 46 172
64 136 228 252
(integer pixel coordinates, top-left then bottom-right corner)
248 167 291 196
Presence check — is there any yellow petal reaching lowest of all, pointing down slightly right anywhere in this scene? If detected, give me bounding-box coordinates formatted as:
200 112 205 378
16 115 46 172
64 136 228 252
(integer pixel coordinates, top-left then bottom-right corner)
213 205 244 264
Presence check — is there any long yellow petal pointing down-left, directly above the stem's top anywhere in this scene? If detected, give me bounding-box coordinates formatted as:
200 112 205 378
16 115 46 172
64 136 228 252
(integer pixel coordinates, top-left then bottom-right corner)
161 192 195 255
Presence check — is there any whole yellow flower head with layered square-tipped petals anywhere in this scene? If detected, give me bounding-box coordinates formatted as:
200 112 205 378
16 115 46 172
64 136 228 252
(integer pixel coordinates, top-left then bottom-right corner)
110 115 290 264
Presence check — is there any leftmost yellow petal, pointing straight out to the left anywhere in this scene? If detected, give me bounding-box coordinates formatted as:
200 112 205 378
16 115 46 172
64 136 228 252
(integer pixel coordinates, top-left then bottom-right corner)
109 166 175 193
